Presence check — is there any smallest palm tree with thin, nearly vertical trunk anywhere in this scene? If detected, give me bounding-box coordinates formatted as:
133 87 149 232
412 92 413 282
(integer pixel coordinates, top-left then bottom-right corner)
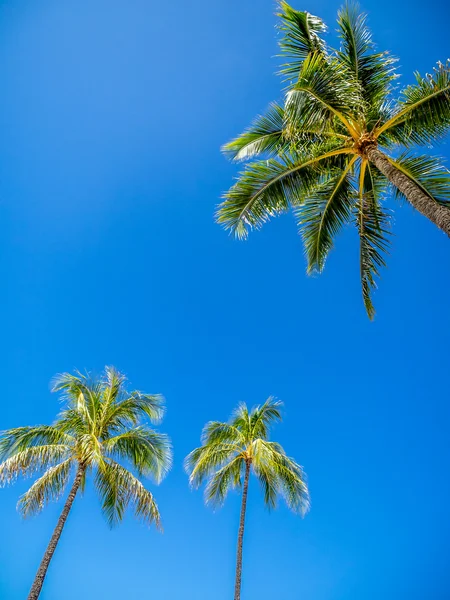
185 398 309 600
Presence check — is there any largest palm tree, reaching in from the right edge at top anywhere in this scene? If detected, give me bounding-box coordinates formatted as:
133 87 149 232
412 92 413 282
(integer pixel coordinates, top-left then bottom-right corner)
217 2 450 319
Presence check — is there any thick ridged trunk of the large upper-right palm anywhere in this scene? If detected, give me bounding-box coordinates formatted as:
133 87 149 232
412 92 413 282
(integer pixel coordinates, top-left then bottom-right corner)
366 146 450 237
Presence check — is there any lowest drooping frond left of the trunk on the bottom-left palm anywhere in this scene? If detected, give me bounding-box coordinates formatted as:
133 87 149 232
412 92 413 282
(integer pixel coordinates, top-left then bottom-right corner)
17 457 73 517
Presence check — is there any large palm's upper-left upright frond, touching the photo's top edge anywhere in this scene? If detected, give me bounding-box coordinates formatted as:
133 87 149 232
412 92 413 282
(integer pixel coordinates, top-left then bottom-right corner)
277 1 326 79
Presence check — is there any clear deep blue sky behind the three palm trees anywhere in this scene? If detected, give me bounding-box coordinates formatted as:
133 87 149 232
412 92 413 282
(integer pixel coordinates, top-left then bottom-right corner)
0 0 450 600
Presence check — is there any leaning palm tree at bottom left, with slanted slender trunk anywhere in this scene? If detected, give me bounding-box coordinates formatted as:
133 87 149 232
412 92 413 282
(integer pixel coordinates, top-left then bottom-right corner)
0 367 172 600
